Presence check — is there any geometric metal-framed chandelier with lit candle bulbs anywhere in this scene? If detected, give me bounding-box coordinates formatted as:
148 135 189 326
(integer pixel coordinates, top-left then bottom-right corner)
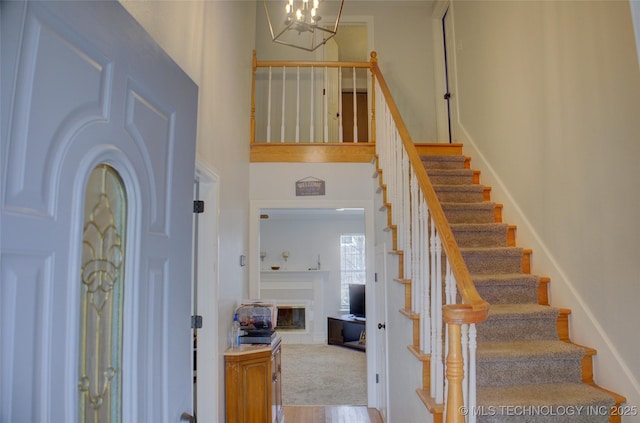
264 0 344 51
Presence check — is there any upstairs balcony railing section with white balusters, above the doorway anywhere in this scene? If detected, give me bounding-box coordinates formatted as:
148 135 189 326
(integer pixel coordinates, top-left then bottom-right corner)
251 52 375 162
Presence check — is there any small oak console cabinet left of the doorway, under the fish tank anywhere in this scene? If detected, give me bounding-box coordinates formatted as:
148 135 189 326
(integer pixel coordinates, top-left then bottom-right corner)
224 338 284 423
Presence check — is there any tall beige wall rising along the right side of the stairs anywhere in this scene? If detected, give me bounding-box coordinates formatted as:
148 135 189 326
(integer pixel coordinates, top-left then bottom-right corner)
453 1 640 414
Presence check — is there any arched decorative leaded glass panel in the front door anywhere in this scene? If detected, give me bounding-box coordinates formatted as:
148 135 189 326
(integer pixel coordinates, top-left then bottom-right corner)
78 164 127 423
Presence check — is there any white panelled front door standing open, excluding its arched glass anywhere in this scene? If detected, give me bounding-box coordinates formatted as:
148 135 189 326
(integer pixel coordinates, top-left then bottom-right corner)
0 1 197 422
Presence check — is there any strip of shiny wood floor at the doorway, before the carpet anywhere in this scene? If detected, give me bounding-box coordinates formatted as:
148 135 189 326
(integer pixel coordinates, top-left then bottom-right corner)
282 405 383 423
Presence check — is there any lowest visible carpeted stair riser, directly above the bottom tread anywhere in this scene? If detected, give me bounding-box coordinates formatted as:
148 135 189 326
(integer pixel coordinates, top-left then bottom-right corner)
476 359 582 387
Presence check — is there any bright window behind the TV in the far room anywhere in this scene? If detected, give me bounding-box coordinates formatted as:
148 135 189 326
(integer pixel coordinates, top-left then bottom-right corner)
340 234 367 310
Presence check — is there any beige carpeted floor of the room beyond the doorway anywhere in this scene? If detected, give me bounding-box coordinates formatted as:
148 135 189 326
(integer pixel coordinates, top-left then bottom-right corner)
282 344 367 405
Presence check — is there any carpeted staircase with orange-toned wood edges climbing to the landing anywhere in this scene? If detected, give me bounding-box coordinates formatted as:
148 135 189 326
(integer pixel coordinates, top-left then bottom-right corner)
384 145 626 423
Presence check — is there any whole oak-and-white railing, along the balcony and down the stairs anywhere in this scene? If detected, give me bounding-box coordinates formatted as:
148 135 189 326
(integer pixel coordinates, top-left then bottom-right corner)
251 52 489 423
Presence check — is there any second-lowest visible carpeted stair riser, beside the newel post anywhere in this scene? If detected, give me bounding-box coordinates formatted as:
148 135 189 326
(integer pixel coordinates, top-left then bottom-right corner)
476 317 558 342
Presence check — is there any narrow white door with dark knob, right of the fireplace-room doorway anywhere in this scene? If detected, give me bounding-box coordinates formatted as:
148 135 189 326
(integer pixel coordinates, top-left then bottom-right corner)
375 243 391 422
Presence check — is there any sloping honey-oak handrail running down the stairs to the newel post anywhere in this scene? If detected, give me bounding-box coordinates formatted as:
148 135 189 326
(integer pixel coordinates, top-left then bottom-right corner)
371 52 489 323
